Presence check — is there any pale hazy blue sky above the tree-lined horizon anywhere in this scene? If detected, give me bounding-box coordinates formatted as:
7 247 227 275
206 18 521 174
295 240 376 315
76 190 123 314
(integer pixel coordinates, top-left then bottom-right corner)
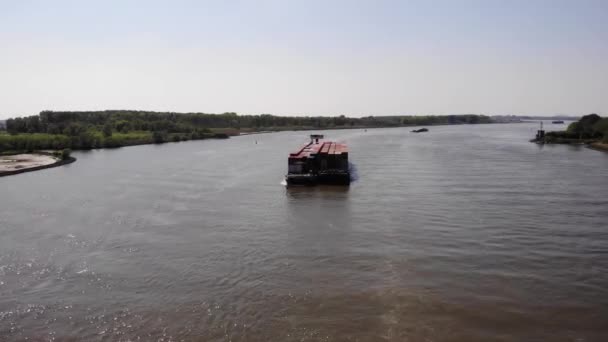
0 0 608 119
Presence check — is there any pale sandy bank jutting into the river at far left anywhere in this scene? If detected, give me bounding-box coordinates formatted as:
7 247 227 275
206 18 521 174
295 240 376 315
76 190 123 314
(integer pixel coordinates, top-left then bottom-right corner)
0 153 76 177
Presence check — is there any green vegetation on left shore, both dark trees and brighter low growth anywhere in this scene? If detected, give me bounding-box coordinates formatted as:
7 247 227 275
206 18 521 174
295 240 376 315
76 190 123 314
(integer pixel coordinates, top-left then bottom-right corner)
0 110 492 153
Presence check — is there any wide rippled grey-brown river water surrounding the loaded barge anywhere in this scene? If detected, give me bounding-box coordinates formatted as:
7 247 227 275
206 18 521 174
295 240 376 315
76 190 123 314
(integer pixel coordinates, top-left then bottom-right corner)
0 124 608 341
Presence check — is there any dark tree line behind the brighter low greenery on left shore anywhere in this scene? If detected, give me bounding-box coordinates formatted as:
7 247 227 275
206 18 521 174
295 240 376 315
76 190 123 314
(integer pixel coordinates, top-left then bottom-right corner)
6 110 491 135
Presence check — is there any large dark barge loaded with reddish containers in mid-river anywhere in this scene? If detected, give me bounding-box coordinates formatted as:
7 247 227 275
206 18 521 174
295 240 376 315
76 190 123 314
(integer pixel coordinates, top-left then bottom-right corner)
285 134 350 186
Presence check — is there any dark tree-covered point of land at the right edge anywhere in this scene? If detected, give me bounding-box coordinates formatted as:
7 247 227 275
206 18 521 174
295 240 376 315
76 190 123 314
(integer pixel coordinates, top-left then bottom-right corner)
531 114 608 151
